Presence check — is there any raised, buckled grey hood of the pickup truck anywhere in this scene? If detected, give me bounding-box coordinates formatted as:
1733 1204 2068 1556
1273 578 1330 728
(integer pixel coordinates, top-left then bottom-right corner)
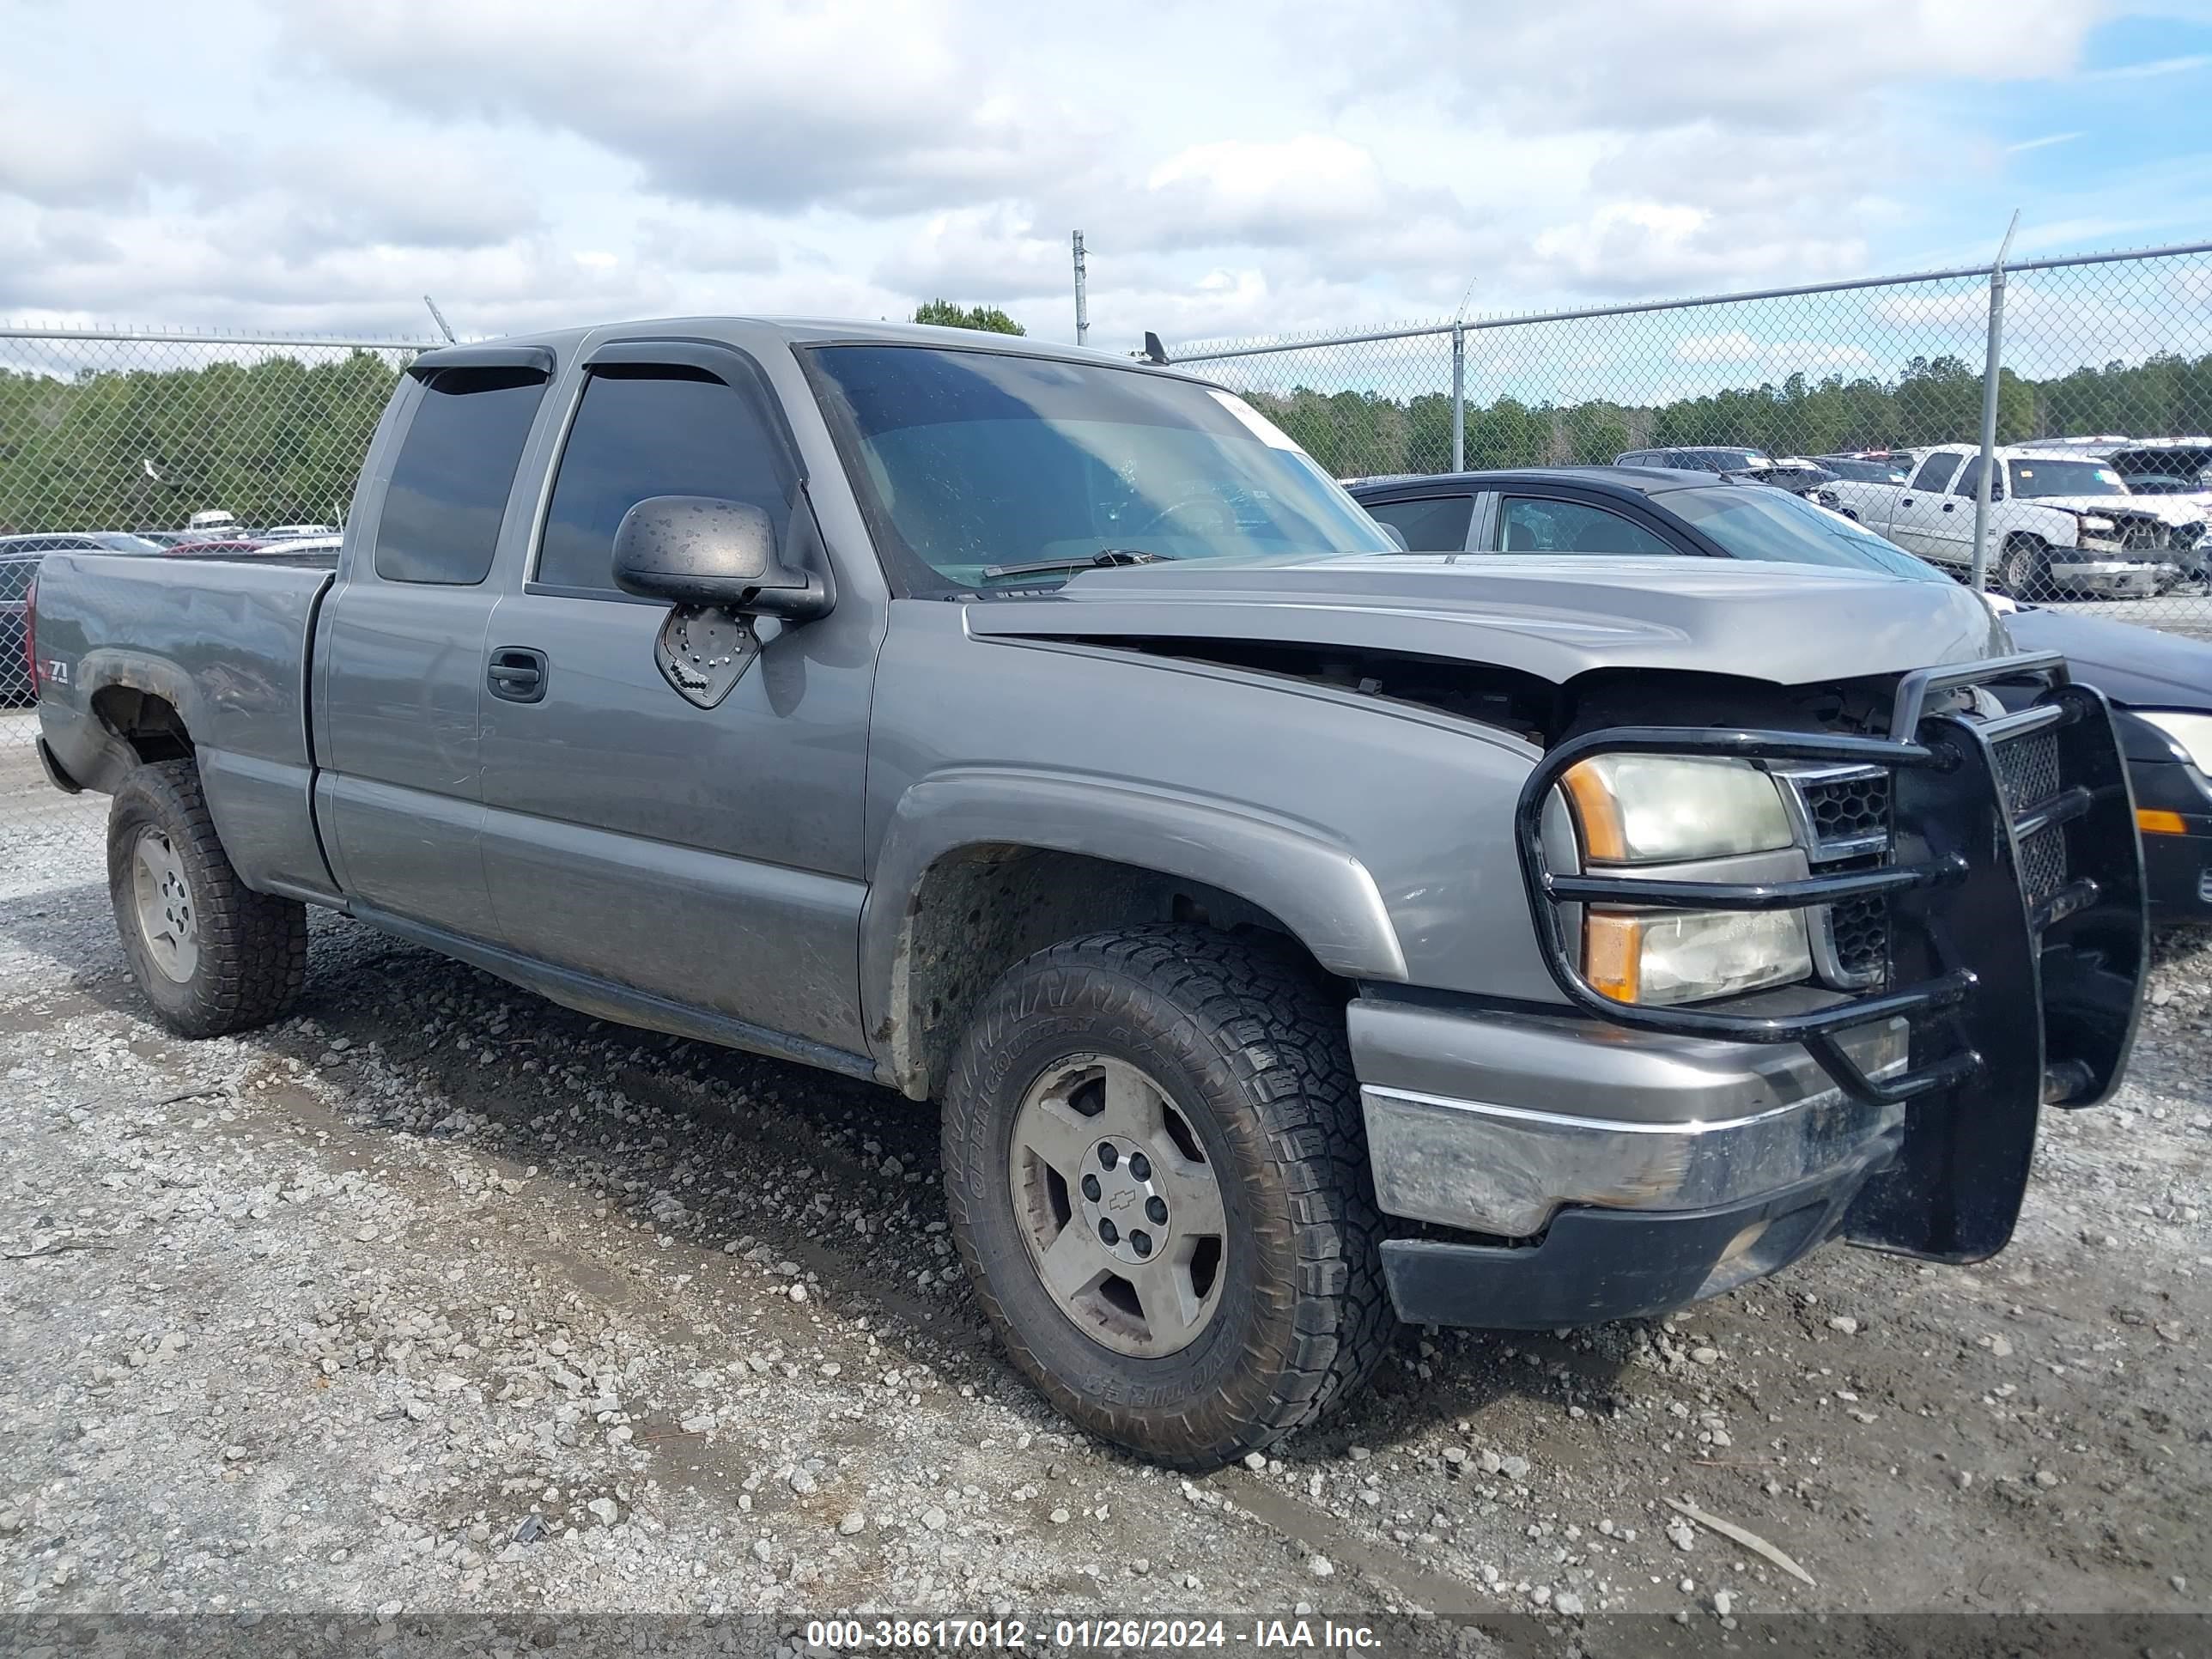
967 553 2008 686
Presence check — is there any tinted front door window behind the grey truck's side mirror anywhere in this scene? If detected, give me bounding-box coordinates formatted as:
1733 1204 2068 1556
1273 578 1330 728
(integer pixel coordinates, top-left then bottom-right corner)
533 362 796 598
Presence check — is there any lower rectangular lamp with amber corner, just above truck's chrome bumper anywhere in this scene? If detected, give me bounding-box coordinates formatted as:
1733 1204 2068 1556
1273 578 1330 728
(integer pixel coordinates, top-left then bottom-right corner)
1582 907 1812 1005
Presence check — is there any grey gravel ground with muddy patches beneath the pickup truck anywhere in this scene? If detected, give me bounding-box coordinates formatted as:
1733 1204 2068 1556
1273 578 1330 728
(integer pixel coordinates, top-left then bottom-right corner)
0 730 2212 1631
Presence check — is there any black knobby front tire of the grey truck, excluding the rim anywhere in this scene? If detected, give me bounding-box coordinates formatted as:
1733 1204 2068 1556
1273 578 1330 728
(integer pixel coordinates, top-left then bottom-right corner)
945 927 1395 1468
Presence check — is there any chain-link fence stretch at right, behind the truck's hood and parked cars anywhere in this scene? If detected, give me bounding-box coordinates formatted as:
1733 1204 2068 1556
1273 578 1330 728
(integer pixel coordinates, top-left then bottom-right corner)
1172 243 2212 639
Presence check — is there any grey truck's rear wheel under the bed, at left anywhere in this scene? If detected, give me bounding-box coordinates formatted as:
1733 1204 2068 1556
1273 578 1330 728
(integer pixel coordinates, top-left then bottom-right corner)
108 761 307 1037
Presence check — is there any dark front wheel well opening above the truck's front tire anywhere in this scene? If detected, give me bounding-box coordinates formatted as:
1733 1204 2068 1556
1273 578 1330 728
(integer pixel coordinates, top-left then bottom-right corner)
878 842 1322 1099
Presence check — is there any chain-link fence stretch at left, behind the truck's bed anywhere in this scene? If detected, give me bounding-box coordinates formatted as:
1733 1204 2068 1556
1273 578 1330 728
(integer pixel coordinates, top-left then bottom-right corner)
0 327 434 883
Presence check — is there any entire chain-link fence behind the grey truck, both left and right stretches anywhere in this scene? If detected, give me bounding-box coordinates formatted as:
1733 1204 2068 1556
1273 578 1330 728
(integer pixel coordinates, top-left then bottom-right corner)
0 243 2212 876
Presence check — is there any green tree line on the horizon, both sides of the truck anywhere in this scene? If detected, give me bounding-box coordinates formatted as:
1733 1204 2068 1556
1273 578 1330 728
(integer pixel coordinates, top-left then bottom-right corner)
0 340 2212 533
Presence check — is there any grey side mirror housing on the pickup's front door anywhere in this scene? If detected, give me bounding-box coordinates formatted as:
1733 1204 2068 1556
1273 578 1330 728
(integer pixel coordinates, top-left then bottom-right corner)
615 495 830 622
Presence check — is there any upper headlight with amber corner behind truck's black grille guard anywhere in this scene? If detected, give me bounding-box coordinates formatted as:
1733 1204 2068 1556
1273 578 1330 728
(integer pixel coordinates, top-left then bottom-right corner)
1562 754 1792 865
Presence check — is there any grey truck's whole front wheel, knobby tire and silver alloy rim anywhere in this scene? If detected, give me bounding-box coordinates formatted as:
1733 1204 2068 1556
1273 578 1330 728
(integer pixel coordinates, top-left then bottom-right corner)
945 927 1395 1468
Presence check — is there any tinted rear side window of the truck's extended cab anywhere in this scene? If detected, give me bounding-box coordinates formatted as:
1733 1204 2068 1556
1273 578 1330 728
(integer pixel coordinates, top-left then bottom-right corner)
376 369 546 586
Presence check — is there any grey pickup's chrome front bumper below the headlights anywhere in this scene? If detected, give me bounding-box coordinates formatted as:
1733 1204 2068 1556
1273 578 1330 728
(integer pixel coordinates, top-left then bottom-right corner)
1352 998 1905 1239
